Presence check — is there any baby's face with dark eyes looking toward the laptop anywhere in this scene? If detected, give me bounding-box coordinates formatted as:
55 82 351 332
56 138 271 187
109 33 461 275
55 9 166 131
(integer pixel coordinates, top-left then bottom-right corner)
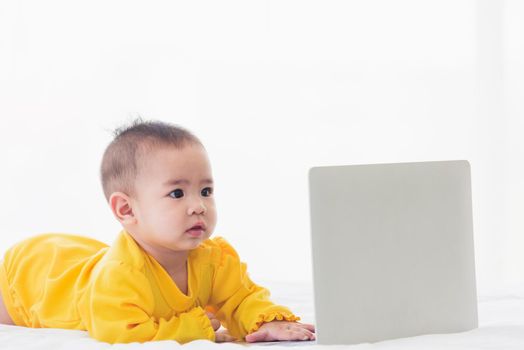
133 145 216 251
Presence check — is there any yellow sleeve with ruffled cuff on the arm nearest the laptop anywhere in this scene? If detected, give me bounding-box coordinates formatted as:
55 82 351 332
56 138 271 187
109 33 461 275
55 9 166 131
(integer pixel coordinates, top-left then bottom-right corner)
209 237 300 339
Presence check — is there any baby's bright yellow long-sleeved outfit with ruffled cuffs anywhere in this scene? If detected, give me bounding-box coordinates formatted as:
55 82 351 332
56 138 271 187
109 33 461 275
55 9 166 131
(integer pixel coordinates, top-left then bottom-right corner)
0 230 300 344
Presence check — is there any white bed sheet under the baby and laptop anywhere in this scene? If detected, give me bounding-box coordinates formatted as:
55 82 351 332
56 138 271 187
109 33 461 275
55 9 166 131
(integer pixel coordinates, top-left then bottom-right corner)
0 281 524 350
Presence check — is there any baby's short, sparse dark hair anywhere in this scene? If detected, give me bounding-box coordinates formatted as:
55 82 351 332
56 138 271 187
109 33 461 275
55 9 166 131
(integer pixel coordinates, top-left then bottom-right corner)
100 117 204 202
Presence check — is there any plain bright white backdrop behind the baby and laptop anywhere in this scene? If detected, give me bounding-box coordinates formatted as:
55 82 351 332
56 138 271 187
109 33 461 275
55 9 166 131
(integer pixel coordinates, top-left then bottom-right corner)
0 0 524 293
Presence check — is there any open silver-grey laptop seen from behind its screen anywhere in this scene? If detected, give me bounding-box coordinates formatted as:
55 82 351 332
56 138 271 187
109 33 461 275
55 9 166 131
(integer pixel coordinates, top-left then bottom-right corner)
252 160 478 346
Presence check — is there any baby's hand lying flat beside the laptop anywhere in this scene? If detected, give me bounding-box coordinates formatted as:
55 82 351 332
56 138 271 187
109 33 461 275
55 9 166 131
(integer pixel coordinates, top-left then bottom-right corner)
246 321 315 343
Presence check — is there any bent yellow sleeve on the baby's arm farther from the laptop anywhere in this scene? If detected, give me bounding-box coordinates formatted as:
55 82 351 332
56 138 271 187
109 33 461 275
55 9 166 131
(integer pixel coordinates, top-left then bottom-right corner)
79 261 215 344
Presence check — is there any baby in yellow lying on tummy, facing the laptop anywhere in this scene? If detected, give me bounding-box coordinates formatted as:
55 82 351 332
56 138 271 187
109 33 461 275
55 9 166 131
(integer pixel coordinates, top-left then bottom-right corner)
0 118 315 343
